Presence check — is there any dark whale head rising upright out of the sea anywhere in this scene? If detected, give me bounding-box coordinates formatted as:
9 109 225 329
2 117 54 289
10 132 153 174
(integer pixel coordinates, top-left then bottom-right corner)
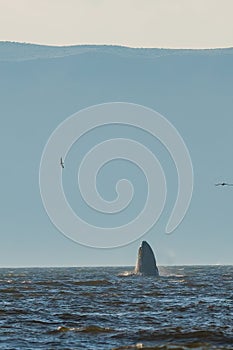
135 241 159 276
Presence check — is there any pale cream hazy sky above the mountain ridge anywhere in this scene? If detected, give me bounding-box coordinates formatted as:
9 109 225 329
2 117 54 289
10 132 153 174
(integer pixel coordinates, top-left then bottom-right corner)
0 0 233 48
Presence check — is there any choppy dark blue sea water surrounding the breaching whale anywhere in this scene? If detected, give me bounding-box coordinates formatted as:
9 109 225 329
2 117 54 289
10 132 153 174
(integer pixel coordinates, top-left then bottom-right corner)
0 266 233 350
